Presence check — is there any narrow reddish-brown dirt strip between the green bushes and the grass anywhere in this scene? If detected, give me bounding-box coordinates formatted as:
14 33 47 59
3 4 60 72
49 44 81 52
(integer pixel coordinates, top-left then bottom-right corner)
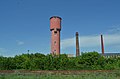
0 70 114 75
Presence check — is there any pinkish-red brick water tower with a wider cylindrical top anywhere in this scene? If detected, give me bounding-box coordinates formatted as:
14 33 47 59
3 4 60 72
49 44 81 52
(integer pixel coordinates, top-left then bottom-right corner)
50 16 61 55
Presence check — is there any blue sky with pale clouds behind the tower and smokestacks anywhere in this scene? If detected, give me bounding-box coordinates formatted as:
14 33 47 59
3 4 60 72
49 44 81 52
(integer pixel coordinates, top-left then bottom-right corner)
0 0 120 56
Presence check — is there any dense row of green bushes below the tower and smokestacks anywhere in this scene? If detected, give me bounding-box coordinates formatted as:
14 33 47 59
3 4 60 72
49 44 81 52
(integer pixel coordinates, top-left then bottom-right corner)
0 52 120 70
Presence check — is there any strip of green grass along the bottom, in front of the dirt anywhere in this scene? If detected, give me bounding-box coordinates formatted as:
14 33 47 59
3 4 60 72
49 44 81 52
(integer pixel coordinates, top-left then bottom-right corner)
0 71 120 79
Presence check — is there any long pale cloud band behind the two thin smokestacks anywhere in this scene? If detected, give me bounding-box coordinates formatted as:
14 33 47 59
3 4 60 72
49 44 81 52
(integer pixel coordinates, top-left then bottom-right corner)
61 34 120 49
